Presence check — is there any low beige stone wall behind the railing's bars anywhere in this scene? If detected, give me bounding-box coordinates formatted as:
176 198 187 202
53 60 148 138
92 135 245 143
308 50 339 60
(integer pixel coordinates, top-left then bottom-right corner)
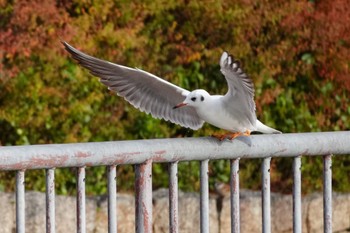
0 189 350 233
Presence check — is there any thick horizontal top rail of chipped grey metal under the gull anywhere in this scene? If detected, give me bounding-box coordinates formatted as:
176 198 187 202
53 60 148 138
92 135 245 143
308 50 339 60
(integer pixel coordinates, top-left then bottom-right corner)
0 131 350 170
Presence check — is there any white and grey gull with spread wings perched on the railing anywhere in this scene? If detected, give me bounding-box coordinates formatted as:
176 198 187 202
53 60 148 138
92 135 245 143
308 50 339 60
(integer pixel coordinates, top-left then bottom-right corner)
62 41 281 141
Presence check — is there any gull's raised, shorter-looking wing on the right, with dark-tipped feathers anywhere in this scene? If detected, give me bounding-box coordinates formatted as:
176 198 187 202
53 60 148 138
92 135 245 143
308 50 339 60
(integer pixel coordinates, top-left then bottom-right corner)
220 52 256 126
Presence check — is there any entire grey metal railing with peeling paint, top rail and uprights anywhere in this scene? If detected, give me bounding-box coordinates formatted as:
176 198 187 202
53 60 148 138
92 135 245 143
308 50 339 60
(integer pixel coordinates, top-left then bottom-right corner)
0 132 350 233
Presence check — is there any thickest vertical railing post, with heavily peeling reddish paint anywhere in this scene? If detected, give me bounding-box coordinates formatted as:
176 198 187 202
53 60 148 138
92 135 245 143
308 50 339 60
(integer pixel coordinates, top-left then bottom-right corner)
135 160 152 233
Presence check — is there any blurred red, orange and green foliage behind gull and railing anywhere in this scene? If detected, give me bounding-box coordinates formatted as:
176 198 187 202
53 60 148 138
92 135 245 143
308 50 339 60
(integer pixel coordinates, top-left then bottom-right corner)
0 0 350 194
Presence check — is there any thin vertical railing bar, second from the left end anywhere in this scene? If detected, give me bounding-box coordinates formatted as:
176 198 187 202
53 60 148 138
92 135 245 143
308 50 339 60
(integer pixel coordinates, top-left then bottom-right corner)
46 168 55 233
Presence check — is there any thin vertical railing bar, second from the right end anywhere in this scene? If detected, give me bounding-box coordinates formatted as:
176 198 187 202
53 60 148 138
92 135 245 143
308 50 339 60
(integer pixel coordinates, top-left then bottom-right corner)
293 156 302 233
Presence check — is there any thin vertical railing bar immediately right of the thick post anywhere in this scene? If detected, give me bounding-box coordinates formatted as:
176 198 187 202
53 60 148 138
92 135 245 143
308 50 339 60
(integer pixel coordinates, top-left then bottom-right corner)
169 162 179 233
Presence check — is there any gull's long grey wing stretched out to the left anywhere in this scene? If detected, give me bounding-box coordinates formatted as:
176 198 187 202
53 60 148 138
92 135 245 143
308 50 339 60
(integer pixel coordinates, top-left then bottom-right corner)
62 42 204 129
